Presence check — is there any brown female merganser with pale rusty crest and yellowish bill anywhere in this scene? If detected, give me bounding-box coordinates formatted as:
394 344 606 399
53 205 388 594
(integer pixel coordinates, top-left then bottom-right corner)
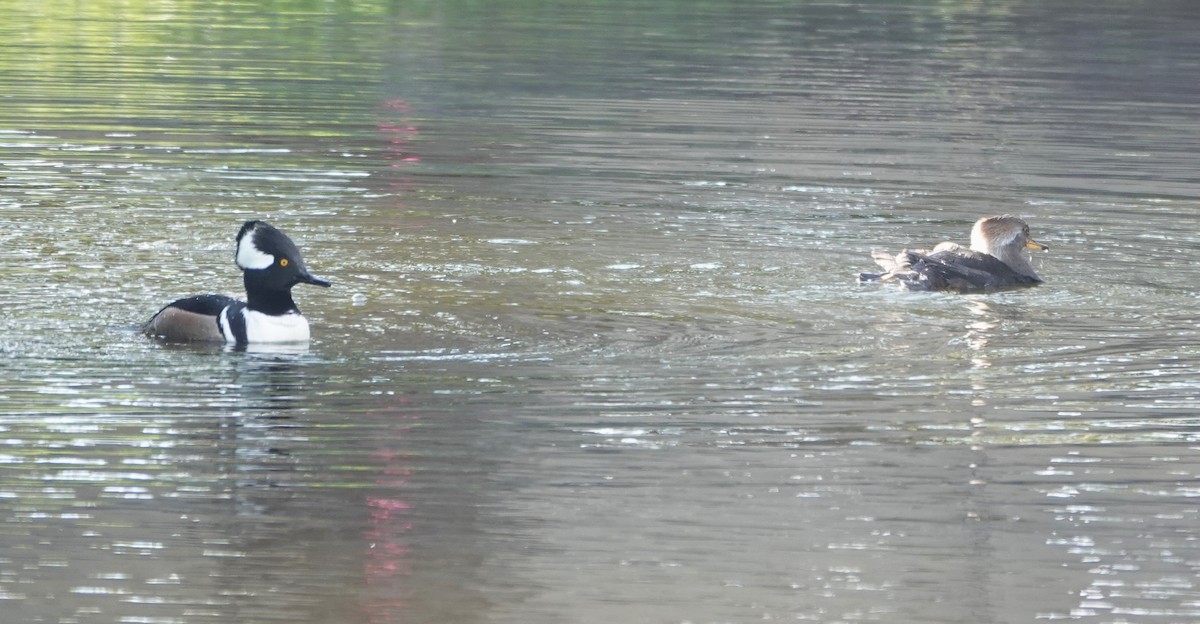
858 215 1050 290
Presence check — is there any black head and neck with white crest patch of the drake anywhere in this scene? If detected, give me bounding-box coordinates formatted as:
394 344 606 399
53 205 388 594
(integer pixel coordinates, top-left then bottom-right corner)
234 221 330 308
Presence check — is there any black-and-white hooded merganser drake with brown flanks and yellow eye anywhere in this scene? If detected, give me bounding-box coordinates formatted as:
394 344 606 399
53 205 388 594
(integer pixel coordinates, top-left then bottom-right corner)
144 221 330 344
